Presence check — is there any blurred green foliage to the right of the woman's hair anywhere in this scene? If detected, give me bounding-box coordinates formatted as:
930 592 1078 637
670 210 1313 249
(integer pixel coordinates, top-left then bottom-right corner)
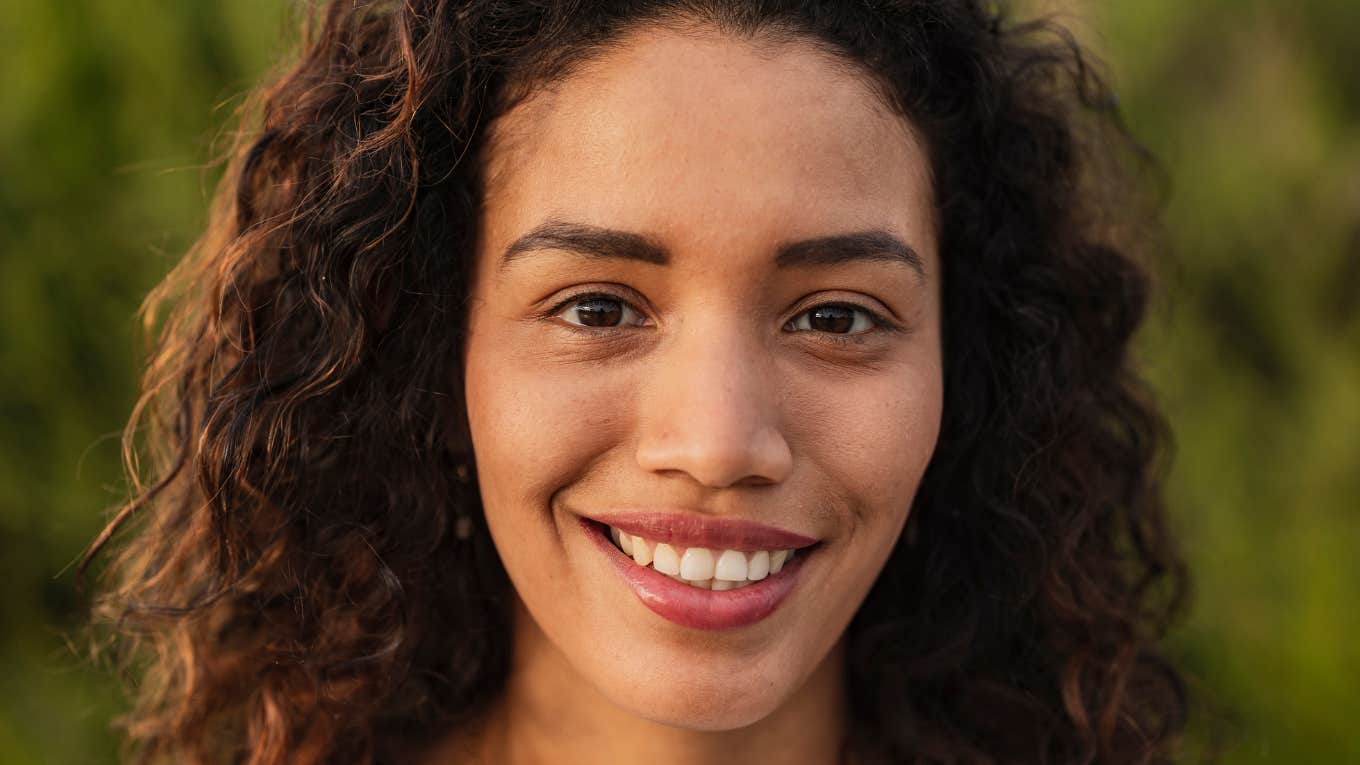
1093 0 1360 762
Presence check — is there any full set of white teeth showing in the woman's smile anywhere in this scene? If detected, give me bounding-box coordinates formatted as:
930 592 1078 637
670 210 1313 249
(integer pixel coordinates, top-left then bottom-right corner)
609 525 793 592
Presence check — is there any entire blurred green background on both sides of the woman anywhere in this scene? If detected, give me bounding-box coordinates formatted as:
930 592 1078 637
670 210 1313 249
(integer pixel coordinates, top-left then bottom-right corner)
0 0 1360 764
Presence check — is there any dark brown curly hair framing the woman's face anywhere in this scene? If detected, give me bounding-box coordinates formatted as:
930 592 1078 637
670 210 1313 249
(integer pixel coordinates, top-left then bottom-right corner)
82 0 1189 765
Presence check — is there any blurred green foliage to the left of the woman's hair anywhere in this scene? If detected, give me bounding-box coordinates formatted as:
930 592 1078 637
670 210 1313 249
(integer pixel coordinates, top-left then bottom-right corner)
0 0 288 764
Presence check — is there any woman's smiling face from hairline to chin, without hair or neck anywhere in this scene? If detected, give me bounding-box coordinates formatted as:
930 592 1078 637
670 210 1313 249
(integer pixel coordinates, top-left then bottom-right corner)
464 30 941 730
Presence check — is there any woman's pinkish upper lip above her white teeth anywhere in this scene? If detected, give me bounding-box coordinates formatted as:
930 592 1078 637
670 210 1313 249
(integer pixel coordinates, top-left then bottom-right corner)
579 508 817 550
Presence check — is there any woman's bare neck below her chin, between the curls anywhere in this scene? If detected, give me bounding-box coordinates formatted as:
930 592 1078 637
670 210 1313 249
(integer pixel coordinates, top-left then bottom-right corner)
431 599 847 765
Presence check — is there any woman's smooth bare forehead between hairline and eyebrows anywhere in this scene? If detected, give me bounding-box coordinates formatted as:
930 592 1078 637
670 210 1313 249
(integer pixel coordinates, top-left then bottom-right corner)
484 29 934 268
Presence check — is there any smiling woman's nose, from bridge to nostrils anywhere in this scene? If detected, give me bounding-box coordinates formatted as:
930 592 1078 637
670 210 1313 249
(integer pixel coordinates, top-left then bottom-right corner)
638 320 793 489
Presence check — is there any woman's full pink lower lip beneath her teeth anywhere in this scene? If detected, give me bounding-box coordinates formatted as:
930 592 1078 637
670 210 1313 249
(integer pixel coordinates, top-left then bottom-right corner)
581 519 808 630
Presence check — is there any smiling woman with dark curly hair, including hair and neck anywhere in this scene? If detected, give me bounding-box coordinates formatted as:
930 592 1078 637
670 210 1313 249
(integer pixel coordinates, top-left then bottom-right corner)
82 0 1186 764
